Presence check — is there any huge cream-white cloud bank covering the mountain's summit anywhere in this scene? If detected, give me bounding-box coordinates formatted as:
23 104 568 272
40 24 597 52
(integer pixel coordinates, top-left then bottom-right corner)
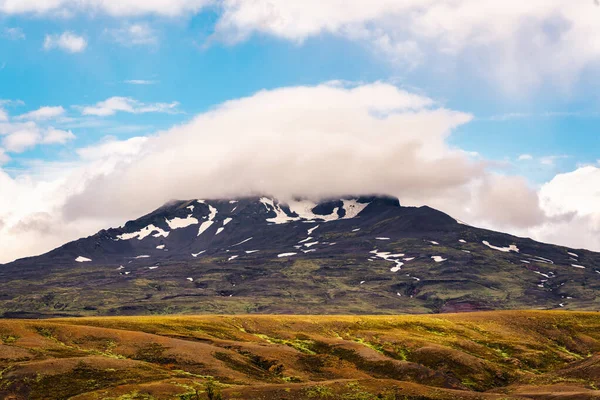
0 82 600 261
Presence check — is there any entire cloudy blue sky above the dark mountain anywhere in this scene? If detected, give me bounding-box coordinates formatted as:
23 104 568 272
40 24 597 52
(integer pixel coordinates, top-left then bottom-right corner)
0 0 600 263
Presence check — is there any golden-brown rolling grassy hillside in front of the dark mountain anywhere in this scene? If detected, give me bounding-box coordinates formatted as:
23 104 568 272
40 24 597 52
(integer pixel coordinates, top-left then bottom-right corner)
0 311 600 400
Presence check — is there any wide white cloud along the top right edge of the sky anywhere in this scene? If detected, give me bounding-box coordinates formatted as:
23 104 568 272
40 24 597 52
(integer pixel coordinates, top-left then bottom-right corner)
216 0 600 94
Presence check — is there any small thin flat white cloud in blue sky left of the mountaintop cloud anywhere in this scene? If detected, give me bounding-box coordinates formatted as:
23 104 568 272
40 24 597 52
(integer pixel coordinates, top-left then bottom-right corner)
79 96 179 117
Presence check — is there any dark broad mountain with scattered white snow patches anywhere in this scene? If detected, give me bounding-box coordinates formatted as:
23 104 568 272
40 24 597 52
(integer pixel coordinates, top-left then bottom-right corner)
0 196 600 317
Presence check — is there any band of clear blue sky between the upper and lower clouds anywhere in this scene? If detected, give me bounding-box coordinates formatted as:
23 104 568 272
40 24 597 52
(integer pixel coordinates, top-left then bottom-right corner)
0 3 599 183
